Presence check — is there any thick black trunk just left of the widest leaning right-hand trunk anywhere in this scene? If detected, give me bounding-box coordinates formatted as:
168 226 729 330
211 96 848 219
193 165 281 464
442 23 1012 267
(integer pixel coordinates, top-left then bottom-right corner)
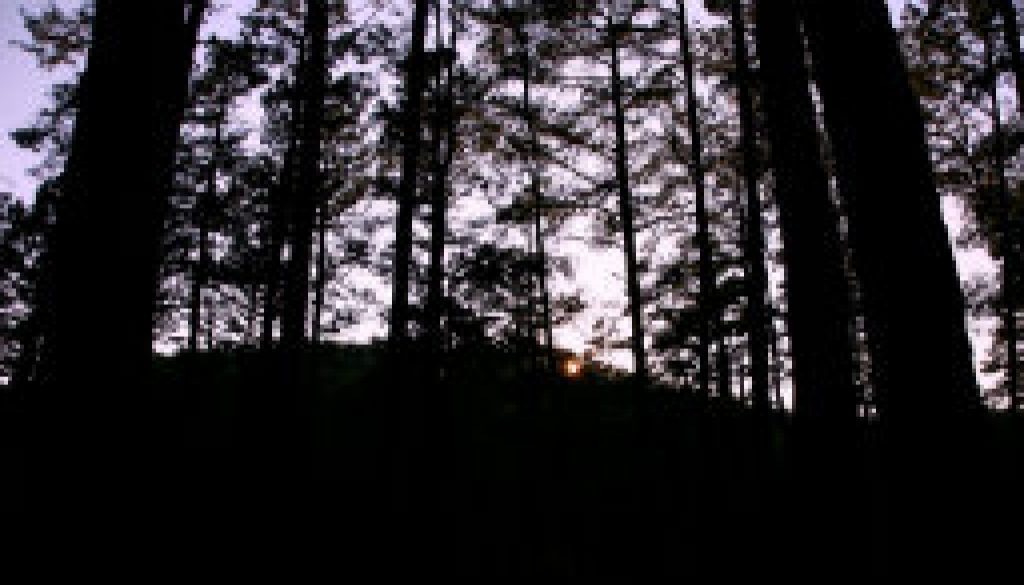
757 0 857 431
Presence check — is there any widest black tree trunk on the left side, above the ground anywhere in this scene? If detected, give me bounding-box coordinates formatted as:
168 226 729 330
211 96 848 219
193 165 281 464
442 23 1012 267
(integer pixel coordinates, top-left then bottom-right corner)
53 0 205 399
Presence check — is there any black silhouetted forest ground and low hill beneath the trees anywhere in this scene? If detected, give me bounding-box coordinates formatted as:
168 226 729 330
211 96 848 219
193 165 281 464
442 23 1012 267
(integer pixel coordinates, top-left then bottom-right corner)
3 348 1024 582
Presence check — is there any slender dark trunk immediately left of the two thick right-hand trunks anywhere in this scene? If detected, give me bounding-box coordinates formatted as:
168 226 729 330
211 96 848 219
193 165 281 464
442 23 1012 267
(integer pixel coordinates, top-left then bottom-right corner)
732 0 771 413
